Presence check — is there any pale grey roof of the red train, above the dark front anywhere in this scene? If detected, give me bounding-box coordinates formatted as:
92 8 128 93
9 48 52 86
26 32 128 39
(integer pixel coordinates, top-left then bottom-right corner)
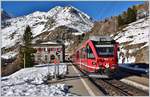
89 36 114 41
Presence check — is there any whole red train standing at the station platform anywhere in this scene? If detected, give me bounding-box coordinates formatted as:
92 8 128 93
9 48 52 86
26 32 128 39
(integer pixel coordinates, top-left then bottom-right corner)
71 36 119 78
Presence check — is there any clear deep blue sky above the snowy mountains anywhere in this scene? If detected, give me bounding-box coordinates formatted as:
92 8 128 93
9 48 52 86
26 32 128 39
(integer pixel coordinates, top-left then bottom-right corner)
1 1 144 20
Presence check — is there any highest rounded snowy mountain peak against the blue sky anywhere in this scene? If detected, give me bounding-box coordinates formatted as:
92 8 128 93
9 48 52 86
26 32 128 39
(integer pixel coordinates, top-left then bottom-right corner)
42 6 93 33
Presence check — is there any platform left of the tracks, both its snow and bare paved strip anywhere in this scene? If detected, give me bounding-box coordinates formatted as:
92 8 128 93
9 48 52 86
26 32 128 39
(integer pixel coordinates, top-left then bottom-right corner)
1 63 103 96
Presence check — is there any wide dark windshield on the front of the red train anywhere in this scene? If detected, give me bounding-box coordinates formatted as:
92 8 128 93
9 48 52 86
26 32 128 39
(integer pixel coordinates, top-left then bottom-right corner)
96 45 114 57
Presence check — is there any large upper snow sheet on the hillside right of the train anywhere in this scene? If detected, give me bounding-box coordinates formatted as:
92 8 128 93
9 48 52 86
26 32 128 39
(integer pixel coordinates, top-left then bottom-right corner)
114 18 150 45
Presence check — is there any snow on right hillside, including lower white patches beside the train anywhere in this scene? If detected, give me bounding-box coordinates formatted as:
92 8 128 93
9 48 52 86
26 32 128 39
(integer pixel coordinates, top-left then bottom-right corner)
114 17 150 63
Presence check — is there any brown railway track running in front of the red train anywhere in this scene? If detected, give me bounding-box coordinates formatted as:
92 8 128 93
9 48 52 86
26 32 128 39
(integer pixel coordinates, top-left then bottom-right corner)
71 62 149 96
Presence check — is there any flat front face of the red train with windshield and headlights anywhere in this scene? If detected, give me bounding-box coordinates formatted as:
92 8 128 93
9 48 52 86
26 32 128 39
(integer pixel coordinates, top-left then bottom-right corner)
94 36 118 76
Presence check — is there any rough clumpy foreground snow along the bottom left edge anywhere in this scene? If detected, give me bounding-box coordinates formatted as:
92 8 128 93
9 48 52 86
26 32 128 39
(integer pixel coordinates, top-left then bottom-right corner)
2 83 71 96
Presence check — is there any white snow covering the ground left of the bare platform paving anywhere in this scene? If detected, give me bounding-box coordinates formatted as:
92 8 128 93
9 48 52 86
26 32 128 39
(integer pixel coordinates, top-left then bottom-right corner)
1 64 72 96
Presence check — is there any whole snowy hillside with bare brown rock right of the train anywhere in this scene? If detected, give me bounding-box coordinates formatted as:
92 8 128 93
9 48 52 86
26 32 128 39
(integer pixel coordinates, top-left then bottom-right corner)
112 17 150 63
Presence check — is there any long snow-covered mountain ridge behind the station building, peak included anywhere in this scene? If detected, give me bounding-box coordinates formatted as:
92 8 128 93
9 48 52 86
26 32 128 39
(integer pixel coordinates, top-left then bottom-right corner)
2 6 93 48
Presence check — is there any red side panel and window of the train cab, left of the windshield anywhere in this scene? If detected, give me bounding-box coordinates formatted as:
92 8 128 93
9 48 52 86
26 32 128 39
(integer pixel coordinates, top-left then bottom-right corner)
86 45 96 72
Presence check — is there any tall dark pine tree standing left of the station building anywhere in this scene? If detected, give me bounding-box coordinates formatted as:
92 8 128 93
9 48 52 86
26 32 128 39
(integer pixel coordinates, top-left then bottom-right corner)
20 26 36 67
